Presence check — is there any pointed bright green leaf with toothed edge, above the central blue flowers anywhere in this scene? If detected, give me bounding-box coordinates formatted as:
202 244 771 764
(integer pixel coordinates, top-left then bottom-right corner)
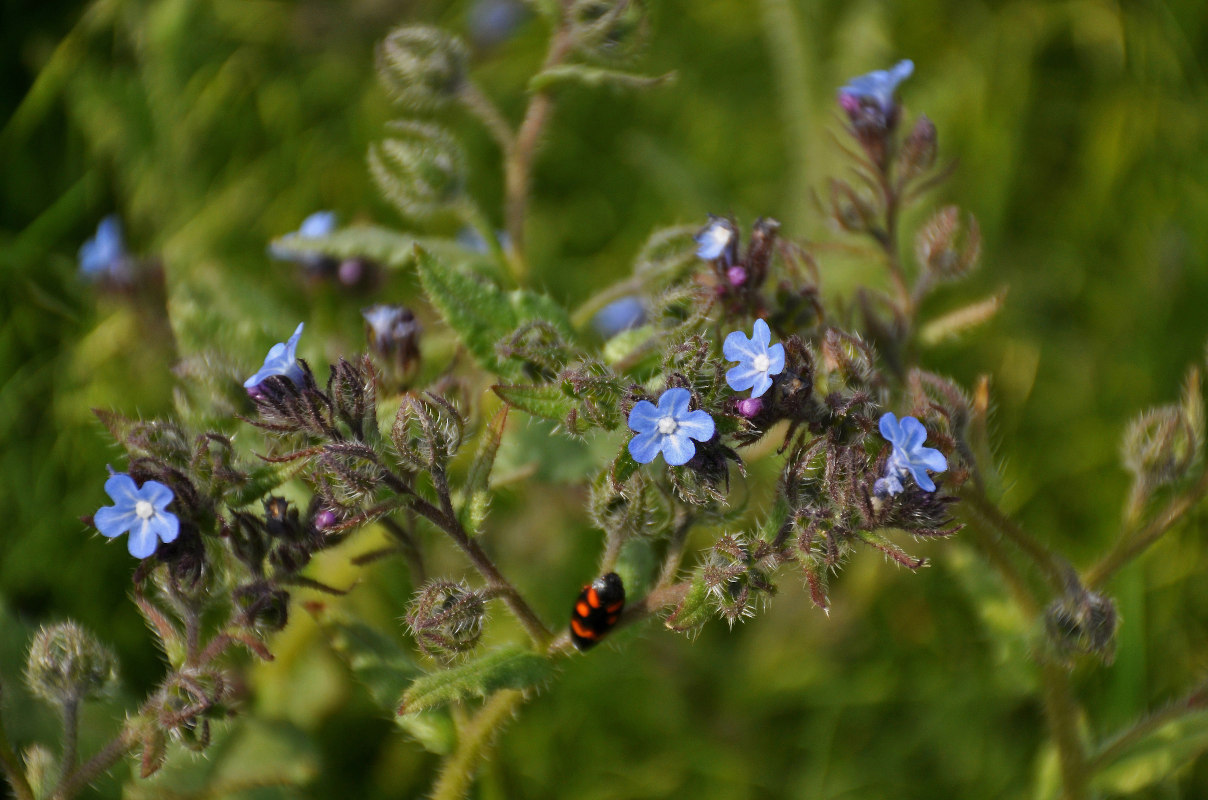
417 249 573 379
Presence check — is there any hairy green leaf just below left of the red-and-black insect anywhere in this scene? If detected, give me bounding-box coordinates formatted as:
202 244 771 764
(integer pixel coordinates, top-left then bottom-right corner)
397 645 553 714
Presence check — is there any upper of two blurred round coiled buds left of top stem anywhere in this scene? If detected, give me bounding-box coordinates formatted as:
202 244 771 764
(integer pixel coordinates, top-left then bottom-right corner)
377 25 467 110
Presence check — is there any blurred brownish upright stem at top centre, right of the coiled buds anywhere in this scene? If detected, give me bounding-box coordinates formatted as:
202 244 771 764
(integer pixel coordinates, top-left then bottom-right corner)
504 7 573 282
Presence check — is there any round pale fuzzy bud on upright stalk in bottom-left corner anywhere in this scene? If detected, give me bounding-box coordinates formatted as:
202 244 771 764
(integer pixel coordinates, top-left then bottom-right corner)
25 622 117 706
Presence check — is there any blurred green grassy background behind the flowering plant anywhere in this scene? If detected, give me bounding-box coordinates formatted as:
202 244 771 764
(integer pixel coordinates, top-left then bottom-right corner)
0 0 1208 800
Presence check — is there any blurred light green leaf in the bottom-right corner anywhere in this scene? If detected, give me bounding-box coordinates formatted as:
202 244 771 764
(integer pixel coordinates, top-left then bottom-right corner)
1093 711 1208 794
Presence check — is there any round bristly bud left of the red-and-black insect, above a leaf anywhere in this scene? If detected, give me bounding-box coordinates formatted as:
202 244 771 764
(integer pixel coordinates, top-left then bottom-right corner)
405 579 487 661
